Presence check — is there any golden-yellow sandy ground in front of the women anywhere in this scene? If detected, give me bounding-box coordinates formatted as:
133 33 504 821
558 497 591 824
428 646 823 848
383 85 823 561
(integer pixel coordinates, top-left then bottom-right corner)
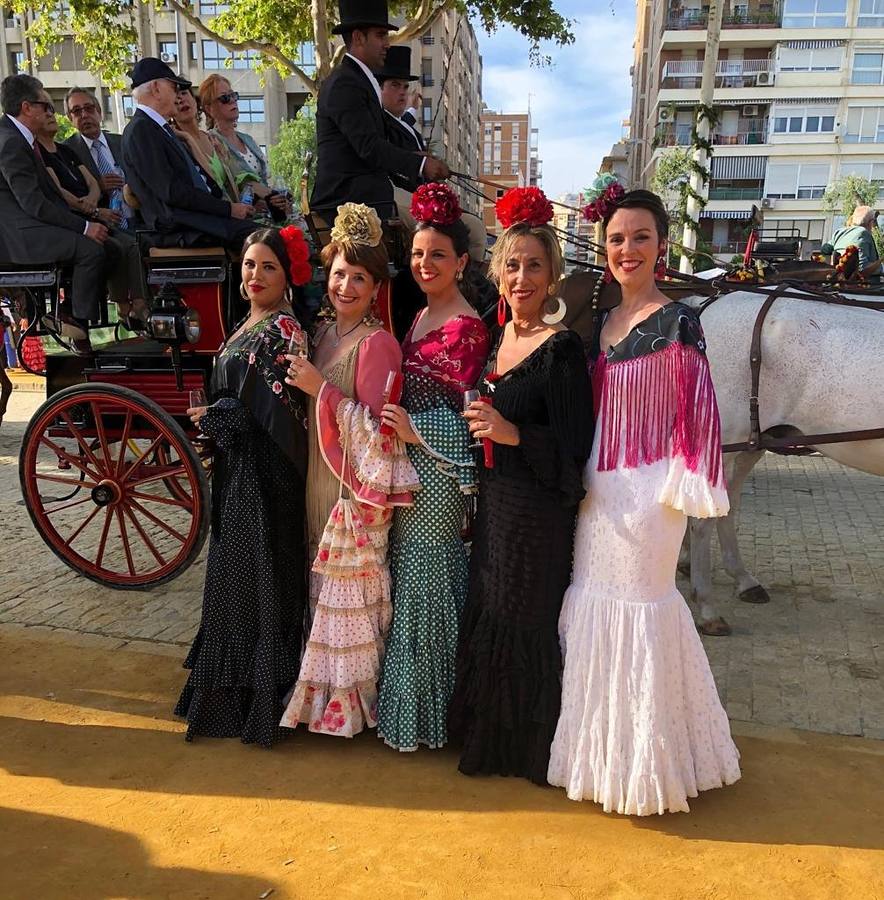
0 626 884 900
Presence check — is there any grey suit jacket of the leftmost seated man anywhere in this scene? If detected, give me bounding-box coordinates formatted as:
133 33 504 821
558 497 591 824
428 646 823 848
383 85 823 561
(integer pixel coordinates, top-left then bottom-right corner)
0 115 86 263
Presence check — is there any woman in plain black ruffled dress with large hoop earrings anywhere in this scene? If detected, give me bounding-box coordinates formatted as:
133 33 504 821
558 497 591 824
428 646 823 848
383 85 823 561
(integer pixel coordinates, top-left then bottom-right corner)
450 188 593 784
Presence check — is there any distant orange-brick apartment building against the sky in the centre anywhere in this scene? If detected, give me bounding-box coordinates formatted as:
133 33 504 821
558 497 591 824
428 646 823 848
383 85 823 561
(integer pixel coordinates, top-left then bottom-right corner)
480 107 543 234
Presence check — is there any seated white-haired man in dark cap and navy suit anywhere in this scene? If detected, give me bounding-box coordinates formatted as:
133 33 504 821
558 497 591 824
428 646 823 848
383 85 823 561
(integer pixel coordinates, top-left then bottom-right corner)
123 56 257 250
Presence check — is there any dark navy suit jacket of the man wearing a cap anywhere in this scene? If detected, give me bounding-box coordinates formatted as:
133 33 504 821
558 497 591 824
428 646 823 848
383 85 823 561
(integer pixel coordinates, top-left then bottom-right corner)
122 109 238 238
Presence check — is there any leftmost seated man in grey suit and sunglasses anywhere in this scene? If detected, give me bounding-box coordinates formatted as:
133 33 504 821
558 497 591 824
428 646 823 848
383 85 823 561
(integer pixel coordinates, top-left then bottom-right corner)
0 75 109 352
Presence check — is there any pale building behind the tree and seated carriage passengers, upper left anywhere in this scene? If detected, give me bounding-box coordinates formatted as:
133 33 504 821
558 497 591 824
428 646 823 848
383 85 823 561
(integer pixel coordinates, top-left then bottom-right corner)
0 0 314 155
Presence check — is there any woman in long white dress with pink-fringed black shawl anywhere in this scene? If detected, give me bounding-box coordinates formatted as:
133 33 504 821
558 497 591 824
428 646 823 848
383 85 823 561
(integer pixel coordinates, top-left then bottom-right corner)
549 185 740 815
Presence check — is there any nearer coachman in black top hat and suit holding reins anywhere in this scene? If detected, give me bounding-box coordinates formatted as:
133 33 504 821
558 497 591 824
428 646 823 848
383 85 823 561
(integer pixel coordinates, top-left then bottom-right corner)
311 0 449 217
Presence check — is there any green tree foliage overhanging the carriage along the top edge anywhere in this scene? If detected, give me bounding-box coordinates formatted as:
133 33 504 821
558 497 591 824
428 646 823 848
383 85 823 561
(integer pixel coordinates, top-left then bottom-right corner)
6 0 574 94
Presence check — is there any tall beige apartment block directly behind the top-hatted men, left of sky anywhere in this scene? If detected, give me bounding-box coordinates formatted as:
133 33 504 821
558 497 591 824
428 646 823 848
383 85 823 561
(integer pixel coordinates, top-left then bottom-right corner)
402 10 482 214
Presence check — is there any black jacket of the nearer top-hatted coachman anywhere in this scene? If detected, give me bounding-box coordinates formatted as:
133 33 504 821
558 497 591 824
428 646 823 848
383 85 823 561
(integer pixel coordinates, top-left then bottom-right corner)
310 56 422 214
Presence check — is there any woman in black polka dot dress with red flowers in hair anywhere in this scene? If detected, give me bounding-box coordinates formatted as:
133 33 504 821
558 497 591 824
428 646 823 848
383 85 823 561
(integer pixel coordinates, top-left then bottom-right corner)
175 229 309 747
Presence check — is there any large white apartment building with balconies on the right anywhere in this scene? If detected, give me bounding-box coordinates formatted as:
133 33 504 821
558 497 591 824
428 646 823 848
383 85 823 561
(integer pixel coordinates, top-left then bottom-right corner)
629 0 884 259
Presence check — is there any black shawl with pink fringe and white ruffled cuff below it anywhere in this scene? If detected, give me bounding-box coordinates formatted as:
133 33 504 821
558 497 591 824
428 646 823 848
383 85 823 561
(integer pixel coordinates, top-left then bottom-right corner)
592 303 727 516
